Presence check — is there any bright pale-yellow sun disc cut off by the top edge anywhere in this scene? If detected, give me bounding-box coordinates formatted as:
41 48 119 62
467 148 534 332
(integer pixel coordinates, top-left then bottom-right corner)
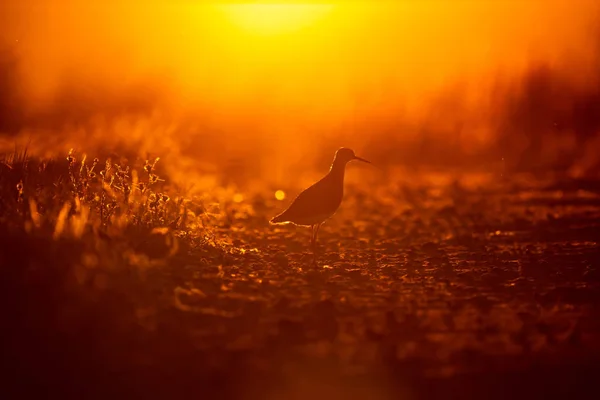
220 3 333 35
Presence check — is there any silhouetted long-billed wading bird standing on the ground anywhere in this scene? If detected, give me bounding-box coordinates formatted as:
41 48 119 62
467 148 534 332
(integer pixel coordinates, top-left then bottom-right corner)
269 147 372 263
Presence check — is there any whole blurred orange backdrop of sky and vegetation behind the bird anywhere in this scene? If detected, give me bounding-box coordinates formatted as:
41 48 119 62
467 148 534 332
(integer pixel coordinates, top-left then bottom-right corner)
0 0 600 189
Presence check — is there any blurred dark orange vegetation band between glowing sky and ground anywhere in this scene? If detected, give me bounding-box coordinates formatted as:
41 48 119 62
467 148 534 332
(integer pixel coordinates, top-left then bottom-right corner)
0 39 600 180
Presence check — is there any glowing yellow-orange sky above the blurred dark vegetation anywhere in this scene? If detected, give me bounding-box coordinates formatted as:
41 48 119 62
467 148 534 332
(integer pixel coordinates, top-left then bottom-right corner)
0 0 598 177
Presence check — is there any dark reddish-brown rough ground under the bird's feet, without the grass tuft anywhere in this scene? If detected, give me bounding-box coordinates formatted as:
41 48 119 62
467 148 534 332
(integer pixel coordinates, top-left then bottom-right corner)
0 173 600 400
